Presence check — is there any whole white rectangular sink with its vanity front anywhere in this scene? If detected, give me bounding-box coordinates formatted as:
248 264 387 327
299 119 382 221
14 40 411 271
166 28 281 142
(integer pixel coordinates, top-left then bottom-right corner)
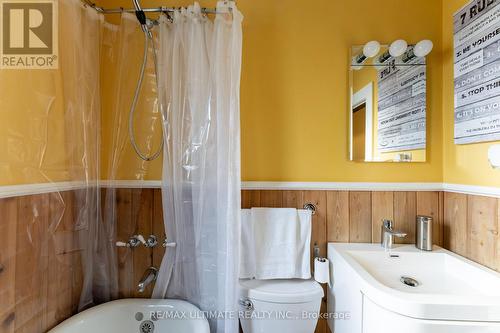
328 243 500 333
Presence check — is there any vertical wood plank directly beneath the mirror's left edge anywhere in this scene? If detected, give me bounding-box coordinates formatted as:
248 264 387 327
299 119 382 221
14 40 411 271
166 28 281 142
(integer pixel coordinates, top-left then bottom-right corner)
349 192 372 243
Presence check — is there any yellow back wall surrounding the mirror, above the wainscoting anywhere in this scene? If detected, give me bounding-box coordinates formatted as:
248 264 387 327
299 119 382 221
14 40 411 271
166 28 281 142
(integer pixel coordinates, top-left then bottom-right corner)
96 0 443 182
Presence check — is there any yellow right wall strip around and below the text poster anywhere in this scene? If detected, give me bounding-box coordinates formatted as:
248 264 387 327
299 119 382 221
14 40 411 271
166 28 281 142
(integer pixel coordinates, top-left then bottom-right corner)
443 0 500 187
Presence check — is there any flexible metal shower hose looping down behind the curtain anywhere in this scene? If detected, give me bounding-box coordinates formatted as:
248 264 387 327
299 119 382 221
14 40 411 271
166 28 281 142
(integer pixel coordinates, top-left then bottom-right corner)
128 31 164 161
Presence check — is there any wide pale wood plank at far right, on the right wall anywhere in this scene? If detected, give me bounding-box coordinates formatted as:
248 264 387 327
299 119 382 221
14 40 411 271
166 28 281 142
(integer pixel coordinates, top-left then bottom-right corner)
467 195 500 269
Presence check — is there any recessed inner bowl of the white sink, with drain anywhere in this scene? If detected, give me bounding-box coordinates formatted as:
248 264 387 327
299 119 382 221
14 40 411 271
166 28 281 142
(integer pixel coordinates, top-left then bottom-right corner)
346 244 500 297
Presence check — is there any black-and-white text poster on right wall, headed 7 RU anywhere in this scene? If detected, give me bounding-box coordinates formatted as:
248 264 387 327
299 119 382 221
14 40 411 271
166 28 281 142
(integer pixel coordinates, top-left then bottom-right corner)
453 0 500 144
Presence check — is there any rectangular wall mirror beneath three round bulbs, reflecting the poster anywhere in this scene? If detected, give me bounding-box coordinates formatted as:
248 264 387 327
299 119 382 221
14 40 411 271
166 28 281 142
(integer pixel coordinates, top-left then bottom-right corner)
349 44 426 162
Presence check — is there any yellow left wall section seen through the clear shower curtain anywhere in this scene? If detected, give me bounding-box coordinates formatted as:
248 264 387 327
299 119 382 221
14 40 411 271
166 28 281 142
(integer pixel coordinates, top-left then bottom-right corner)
0 0 95 186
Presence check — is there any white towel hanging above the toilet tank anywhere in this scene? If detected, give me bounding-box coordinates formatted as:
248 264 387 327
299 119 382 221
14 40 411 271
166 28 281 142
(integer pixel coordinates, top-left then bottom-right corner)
240 208 311 280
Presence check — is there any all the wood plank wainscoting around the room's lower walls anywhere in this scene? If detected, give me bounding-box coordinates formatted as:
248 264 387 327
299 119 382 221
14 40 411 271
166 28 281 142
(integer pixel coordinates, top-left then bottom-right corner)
0 188 500 333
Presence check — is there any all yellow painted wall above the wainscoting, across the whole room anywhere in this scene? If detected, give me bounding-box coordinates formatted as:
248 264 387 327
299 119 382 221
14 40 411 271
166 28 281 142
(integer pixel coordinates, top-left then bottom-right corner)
0 0 500 186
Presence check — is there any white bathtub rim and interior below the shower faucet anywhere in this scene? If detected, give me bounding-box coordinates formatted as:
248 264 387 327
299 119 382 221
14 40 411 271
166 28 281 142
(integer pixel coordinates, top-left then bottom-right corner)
49 298 210 333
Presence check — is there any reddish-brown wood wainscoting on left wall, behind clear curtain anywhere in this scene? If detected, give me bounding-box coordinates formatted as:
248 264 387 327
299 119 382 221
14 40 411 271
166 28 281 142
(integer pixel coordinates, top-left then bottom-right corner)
0 191 83 333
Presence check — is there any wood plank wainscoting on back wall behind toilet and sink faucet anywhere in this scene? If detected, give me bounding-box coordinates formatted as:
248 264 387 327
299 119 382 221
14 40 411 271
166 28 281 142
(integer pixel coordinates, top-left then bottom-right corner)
241 190 443 333
